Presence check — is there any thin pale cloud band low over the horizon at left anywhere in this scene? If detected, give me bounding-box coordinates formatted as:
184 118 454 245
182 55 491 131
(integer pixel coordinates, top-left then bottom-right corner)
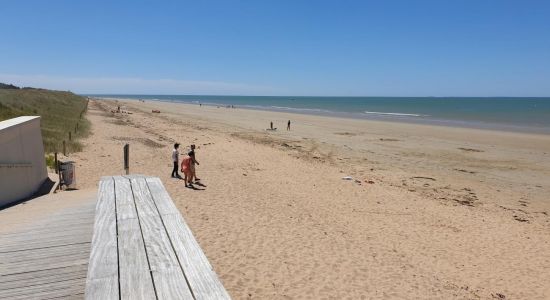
0 74 277 95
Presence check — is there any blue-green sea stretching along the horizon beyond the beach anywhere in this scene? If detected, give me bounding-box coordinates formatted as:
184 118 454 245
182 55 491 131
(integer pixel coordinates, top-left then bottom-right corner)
90 95 550 134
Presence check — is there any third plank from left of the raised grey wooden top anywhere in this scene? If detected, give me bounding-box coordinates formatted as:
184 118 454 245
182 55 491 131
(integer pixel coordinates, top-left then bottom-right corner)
131 178 193 299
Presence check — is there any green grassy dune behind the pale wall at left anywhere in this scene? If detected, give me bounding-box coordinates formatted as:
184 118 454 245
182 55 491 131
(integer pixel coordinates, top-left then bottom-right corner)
0 84 90 153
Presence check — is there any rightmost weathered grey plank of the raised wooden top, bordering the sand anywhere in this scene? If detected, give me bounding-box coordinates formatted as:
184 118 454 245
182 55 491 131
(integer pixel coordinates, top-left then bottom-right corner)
146 178 230 299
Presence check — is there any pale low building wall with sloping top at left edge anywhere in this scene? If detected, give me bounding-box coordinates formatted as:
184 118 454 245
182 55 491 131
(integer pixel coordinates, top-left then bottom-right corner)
0 117 48 207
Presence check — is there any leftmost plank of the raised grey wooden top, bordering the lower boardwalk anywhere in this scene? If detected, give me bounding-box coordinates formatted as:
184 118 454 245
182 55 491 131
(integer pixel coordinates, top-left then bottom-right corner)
85 178 119 300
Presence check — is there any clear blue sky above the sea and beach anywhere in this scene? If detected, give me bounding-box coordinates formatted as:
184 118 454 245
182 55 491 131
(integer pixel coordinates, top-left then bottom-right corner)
0 0 550 96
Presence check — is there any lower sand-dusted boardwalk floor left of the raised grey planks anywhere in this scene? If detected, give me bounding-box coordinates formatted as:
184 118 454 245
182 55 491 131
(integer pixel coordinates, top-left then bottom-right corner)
0 191 97 300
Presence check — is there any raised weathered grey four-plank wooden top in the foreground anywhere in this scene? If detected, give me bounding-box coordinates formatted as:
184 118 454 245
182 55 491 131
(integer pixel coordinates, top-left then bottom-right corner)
86 175 229 300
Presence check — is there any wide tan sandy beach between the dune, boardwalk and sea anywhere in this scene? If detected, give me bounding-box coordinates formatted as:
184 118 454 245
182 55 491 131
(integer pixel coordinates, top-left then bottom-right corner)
66 100 550 299
